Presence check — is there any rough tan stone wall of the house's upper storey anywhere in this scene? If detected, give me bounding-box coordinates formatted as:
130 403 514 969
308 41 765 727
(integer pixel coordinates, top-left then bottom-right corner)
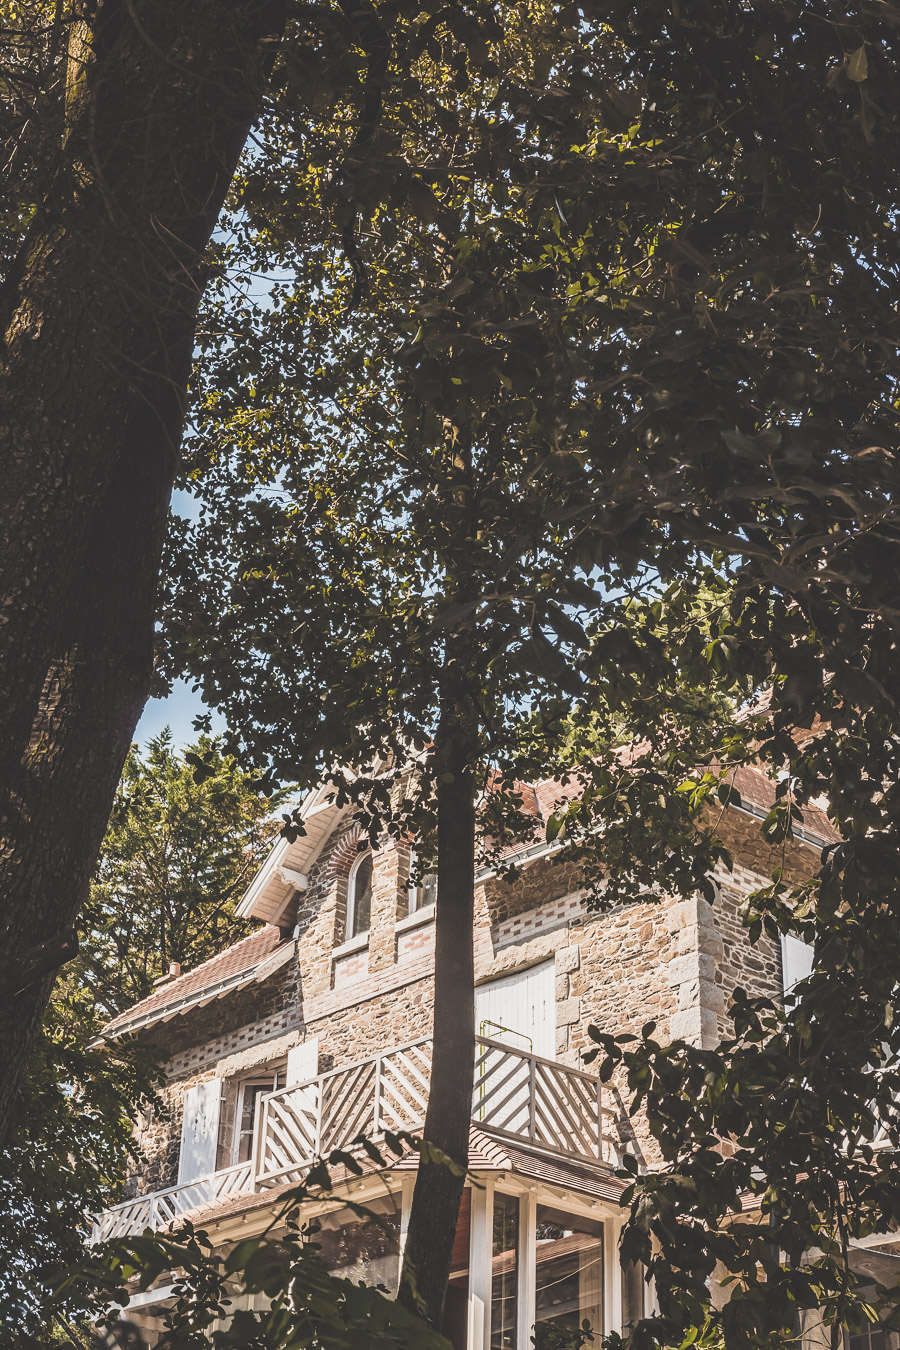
123 810 818 1193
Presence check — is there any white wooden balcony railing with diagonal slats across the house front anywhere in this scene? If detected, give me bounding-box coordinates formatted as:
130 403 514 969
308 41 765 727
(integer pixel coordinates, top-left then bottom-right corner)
92 1035 615 1242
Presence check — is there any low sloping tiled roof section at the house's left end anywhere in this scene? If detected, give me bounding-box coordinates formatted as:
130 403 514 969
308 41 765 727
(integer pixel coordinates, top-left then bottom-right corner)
101 923 294 1040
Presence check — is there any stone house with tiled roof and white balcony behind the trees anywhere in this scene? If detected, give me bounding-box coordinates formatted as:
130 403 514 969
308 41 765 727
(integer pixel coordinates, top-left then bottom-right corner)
94 770 841 1350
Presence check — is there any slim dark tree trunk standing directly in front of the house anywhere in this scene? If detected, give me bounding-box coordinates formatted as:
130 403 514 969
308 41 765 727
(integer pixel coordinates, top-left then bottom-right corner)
399 639 478 1328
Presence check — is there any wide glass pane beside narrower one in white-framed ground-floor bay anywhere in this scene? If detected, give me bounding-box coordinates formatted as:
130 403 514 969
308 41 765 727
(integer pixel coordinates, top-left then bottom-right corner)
534 1204 603 1350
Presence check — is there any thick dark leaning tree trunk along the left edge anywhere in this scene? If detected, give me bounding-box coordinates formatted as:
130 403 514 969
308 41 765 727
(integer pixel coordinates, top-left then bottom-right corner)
0 0 283 1141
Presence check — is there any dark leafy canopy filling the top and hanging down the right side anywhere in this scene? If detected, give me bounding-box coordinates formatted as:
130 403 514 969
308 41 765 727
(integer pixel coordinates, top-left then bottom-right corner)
5 0 900 1346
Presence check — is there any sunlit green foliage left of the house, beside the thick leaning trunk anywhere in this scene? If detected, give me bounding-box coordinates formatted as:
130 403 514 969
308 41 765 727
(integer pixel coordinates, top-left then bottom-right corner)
0 732 279 1346
